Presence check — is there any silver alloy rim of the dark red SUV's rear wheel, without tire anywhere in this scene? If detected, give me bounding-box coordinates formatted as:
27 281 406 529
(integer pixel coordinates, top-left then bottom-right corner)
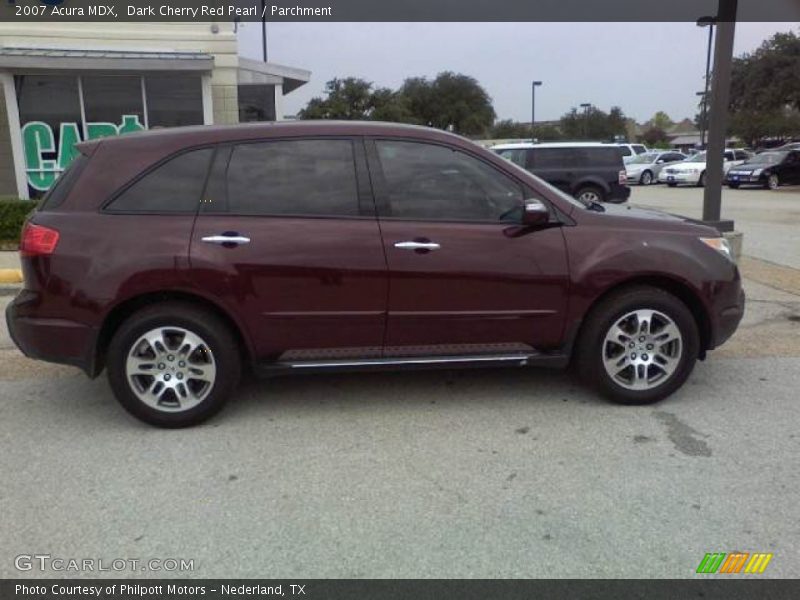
125 327 217 412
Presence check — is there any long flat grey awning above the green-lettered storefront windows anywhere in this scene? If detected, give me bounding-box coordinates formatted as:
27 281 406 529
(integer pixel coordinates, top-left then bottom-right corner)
0 46 214 72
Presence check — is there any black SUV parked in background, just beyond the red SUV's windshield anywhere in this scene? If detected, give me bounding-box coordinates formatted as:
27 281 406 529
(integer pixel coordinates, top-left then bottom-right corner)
492 142 631 203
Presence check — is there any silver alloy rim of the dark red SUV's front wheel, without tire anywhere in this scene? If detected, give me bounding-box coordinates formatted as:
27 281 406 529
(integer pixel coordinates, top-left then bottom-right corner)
602 308 683 390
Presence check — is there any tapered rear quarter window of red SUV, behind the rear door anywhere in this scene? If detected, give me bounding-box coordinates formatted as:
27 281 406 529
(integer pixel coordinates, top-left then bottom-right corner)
107 148 214 213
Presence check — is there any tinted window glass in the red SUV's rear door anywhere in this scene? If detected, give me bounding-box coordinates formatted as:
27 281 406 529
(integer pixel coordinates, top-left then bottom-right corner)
227 140 359 216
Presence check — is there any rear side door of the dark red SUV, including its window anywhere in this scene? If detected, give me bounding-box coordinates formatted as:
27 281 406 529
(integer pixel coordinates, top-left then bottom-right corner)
190 138 388 360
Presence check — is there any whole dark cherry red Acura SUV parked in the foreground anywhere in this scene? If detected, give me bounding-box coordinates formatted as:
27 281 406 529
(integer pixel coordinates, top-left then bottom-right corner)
7 121 744 427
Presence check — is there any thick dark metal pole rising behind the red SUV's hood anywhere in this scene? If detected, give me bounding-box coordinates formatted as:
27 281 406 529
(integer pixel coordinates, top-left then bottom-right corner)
703 0 738 231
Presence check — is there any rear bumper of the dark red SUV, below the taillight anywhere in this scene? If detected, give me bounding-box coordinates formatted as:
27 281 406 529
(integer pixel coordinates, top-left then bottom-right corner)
6 290 97 377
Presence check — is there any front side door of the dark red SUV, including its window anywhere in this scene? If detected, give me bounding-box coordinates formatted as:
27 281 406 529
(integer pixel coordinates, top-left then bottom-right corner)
368 139 568 355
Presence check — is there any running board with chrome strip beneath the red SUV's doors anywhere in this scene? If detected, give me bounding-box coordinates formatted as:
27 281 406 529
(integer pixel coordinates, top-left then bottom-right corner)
256 353 569 375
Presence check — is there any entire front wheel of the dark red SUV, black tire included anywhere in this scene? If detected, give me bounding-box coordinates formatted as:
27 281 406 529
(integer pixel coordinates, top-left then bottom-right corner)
575 286 700 404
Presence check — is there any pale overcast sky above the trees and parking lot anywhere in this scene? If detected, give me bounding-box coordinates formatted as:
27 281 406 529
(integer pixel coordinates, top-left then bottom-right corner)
239 23 800 122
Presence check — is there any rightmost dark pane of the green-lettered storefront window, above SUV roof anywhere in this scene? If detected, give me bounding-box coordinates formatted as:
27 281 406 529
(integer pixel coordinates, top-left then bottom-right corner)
144 75 203 127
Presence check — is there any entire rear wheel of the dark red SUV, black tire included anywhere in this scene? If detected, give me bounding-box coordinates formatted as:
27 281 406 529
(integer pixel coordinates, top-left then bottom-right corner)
106 302 242 428
